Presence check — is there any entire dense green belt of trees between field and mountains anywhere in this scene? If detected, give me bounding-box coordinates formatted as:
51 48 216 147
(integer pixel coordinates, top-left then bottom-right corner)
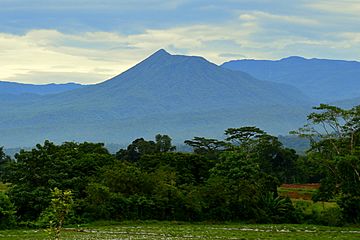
0 105 360 228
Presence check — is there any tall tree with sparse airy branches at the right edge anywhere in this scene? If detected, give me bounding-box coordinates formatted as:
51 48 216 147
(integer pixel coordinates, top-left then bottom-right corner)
295 104 360 223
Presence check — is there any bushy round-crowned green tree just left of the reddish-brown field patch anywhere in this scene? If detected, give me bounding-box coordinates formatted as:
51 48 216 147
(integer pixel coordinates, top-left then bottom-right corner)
205 151 277 221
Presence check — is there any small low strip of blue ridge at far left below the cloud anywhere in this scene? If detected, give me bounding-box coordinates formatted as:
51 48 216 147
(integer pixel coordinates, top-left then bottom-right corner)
0 81 82 95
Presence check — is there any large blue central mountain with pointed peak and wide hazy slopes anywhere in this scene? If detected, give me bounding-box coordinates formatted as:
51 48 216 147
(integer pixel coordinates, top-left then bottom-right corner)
0 50 312 147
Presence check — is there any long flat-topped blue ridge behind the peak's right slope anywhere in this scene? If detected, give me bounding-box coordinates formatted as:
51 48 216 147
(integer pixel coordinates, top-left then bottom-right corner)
222 57 360 104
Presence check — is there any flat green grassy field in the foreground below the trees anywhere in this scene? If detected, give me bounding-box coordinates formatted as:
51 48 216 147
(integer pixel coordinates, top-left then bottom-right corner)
0 222 360 240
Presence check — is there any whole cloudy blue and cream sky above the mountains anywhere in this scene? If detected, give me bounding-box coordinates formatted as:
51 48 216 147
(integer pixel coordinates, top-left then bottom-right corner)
0 0 360 84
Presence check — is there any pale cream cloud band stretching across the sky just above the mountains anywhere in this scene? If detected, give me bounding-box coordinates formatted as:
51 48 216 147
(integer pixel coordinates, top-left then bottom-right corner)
0 8 360 83
